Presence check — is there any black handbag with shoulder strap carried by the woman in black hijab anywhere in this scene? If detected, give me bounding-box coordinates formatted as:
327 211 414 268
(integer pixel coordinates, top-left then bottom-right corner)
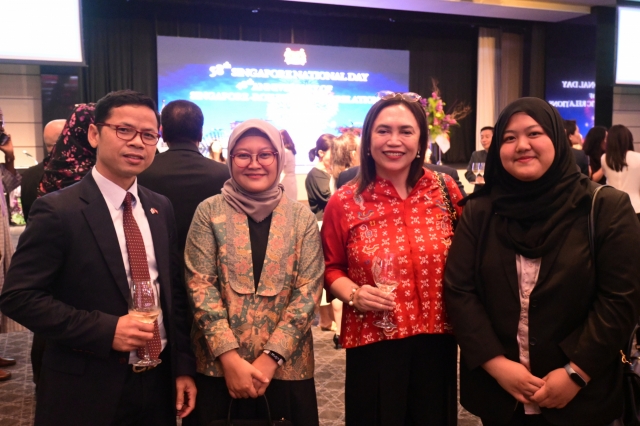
588 185 640 426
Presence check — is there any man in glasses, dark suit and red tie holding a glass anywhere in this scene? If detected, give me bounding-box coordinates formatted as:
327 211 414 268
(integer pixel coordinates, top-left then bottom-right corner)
0 90 196 426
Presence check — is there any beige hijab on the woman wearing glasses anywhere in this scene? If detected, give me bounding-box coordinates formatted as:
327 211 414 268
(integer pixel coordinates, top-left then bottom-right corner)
222 119 284 222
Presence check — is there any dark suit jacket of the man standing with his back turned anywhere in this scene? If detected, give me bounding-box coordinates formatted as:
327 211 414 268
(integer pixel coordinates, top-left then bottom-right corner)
138 144 231 253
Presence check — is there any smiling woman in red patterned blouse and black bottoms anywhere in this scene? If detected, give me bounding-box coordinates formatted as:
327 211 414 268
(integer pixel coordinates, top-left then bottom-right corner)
322 93 461 426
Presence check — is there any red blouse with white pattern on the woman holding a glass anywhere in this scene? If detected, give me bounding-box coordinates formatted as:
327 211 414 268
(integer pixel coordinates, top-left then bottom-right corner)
321 170 462 348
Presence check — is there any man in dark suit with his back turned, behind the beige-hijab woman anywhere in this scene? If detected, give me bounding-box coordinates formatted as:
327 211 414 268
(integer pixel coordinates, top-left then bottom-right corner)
138 100 230 253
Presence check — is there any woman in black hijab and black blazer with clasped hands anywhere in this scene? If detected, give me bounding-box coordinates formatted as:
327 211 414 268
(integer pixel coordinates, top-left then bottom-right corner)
445 98 640 425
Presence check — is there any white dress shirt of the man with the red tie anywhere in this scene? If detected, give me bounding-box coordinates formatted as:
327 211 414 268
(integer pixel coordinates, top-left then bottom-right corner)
91 167 167 364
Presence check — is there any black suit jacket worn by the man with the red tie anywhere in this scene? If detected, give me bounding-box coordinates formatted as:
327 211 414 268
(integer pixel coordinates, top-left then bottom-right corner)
0 173 195 426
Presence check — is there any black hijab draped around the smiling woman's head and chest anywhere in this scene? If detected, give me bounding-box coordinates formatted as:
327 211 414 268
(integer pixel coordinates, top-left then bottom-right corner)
469 98 591 259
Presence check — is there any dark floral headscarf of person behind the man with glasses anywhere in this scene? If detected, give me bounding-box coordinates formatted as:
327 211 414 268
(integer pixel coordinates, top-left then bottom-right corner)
38 103 96 197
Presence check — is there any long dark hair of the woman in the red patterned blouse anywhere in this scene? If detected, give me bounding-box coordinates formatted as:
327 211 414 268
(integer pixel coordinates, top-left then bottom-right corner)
357 96 428 194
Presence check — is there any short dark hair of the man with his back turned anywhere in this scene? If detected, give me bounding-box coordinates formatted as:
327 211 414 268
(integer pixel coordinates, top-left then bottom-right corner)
162 100 204 143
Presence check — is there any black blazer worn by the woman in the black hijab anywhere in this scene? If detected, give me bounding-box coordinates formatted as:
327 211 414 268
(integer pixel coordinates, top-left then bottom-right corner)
445 182 640 425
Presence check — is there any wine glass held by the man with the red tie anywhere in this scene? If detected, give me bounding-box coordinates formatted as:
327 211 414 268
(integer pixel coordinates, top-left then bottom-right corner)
129 280 162 367
